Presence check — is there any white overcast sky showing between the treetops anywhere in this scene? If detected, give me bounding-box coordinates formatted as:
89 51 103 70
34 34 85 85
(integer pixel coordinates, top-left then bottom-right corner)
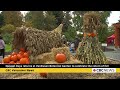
0 11 120 26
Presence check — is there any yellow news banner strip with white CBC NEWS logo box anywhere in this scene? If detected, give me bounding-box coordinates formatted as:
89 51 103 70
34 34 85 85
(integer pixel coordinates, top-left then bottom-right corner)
0 68 120 73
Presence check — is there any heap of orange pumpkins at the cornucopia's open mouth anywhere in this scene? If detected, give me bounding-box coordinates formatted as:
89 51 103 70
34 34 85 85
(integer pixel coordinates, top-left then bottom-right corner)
2 48 30 64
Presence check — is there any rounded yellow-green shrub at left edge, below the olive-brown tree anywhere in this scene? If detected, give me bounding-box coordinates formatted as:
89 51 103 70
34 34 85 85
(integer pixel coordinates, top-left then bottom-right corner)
0 24 16 33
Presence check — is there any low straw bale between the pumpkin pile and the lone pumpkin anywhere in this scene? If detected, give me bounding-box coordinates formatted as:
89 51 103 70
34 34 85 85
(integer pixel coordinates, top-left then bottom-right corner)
31 52 54 64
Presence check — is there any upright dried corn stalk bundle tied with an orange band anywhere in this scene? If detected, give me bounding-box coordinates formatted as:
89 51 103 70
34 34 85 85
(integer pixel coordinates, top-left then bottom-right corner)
76 12 108 64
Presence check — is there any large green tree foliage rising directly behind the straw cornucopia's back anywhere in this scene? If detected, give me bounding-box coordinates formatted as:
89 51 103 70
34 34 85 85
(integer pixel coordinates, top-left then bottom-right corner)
25 11 56 31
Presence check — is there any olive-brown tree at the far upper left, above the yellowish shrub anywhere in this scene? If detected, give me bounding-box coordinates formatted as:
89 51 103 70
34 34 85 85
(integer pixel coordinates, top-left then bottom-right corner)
1 11 23 27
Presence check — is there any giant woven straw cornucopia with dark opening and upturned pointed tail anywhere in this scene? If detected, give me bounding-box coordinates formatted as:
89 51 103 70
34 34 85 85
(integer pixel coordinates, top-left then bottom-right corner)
12 24 63 56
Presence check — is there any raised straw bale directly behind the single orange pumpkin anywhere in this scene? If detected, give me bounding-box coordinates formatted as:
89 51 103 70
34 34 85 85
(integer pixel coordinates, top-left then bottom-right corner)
51 47 71 60
